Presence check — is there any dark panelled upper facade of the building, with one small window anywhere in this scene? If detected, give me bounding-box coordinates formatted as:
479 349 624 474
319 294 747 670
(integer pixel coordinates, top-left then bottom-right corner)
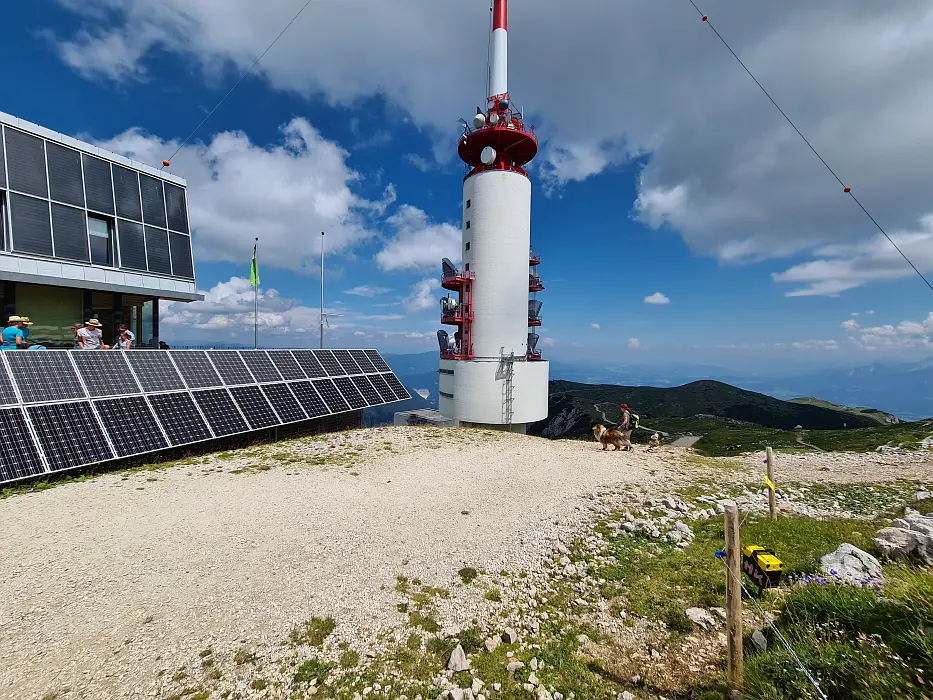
0 124 194 281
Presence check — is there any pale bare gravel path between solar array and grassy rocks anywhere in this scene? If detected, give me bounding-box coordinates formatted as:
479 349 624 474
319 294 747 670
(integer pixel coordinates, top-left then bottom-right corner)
0 428 670 700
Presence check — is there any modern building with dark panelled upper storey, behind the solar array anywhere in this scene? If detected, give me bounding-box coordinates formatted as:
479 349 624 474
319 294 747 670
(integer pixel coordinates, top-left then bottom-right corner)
0 112 203 347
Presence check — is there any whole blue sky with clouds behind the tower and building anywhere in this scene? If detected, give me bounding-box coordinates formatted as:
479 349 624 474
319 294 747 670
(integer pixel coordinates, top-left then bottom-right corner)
0 0 933 370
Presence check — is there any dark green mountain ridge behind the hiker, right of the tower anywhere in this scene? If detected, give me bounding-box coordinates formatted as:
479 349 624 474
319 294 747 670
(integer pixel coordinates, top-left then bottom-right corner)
529 380 878 437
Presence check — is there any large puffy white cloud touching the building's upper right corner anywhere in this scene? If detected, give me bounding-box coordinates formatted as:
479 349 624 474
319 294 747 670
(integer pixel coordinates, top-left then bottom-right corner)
98 118 395 272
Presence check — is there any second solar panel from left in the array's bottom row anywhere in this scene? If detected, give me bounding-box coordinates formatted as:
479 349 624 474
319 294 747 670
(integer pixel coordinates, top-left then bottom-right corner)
26 401 114 471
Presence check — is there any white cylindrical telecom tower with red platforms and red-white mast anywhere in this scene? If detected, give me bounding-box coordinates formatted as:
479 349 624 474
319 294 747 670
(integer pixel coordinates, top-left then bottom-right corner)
438 0 548 433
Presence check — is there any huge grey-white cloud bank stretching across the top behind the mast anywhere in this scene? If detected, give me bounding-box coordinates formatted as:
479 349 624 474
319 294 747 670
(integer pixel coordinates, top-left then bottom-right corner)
49 0 933 282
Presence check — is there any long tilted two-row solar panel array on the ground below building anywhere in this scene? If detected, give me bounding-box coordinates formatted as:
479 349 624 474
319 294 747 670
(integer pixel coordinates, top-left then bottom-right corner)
0 350 411 484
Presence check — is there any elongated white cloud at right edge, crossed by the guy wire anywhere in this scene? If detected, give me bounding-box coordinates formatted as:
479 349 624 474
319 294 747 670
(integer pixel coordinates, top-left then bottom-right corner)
772 214 933 298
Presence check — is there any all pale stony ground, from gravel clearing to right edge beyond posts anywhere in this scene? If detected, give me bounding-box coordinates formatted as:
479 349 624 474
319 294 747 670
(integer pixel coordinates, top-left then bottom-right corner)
0 428 933 700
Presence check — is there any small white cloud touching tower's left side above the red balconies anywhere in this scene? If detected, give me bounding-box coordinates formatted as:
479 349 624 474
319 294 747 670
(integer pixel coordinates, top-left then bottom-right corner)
376 204 461 270
